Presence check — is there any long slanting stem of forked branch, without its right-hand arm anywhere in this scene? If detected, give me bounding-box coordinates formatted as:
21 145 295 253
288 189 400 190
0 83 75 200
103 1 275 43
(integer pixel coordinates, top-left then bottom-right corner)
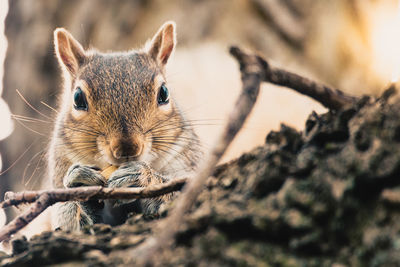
132 47 265 265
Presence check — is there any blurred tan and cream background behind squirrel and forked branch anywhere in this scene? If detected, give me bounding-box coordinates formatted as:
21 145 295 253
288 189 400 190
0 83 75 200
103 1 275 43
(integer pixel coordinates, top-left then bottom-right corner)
0 0 400 206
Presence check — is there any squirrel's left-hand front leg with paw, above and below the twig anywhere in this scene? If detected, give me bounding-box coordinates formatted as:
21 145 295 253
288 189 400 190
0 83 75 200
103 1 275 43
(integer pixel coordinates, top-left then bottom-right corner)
52 164 106 231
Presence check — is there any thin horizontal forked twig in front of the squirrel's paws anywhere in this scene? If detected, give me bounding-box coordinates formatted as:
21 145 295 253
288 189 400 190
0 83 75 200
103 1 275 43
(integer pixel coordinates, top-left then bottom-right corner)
0 178 187 242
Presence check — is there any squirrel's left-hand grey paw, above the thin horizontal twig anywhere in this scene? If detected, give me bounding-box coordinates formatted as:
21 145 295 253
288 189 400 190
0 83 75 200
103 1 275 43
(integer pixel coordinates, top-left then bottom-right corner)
64 164 106 188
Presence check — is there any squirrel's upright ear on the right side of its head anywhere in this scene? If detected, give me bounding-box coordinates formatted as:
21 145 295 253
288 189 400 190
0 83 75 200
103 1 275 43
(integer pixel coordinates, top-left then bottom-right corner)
147 21 176 66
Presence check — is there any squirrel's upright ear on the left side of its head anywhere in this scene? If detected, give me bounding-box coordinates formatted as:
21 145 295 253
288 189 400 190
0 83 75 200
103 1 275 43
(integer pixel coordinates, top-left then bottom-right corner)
54 28 85 77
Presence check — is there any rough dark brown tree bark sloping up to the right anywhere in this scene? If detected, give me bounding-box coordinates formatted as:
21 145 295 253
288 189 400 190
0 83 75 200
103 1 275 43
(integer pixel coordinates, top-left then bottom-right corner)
0 89 400 266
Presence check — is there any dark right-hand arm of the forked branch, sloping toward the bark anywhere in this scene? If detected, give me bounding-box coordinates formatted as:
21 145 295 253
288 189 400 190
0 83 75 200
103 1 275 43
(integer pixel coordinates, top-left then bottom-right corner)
259 57 359 110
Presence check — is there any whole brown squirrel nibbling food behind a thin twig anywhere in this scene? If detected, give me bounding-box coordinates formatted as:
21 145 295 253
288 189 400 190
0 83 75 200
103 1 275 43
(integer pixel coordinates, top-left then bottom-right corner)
45 21 202 231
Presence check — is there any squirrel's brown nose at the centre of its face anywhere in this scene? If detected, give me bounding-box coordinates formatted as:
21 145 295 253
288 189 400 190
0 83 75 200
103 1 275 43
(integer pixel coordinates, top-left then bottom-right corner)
110 137 144 159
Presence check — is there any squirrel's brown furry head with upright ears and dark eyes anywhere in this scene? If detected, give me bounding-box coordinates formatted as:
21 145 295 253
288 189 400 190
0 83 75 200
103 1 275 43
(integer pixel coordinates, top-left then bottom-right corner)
54 22 184 168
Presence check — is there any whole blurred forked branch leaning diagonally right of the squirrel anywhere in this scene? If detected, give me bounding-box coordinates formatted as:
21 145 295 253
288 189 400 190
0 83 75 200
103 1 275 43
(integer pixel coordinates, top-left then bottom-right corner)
129 47 356 266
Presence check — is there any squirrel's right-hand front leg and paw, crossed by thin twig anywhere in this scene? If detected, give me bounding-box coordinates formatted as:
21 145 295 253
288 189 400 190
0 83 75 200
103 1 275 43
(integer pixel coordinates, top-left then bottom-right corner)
108 161 174 214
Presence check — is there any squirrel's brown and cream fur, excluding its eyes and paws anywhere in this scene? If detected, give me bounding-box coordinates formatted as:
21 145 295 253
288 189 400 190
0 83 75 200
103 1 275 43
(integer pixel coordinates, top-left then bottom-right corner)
48 23 201 228
